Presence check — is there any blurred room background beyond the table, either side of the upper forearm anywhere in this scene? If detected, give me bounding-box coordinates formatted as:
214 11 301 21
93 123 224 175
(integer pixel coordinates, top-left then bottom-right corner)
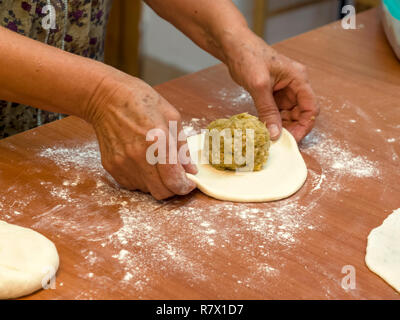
106 0 380 85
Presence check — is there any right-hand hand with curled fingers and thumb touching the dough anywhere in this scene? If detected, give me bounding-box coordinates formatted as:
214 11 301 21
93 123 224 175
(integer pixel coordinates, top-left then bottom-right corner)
226 33 319 142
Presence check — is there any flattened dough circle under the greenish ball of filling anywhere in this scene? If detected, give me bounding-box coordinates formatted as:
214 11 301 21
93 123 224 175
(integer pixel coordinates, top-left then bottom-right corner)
187 129 307 202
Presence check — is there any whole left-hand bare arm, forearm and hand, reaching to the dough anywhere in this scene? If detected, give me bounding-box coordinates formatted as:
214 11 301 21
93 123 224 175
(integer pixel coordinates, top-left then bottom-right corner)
0 26 196 199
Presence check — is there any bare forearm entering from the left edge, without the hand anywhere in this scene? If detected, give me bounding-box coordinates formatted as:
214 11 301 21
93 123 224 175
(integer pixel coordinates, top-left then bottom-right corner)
0 27 112 118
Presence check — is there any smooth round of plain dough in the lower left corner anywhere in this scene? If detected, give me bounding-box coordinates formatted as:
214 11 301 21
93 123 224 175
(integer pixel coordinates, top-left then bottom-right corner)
0 221 59 299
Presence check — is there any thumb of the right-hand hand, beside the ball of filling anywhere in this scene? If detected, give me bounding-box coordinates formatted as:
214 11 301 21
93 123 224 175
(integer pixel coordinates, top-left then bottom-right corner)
252 88 282 140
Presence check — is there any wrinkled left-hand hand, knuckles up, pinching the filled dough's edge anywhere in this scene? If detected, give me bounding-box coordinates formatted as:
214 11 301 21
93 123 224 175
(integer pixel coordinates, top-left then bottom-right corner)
87 72 197 200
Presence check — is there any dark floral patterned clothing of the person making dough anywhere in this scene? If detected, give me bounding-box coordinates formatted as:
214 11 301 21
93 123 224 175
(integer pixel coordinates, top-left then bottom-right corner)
0 0 112 139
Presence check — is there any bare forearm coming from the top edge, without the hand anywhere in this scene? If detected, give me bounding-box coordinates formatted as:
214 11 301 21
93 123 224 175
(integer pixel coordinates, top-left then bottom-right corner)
146 0 251 63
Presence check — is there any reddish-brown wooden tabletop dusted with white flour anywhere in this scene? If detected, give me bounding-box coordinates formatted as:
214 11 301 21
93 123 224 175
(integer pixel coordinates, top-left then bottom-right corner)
0 11 400 299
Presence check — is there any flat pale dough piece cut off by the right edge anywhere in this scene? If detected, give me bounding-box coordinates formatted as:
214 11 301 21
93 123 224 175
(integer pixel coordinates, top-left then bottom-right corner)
365 208 400 292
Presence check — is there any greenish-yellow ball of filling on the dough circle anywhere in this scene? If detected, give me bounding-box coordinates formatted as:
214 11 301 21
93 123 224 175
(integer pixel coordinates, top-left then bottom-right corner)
205 113 270 171
